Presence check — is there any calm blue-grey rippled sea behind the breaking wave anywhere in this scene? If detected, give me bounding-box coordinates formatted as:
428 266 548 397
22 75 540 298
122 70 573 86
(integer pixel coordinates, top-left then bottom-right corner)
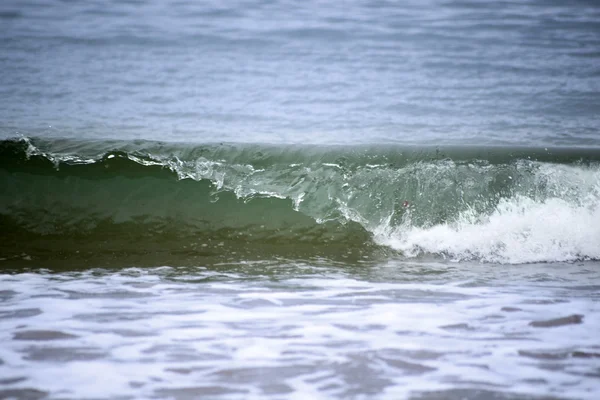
0 0 600 146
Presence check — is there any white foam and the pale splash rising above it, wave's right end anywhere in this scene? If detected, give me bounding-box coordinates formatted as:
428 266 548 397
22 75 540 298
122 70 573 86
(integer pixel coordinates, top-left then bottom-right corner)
375 162 600 264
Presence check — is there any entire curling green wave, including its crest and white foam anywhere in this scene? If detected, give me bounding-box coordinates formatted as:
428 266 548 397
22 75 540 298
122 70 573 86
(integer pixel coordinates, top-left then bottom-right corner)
0 139 600 265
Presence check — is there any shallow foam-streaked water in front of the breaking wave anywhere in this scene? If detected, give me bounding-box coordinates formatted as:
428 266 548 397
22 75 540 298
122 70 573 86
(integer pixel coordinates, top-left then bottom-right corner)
0 261 600 399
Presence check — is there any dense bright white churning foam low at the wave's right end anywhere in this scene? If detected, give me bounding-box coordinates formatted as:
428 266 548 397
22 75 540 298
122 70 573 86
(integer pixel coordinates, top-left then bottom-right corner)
377 196 600 264
